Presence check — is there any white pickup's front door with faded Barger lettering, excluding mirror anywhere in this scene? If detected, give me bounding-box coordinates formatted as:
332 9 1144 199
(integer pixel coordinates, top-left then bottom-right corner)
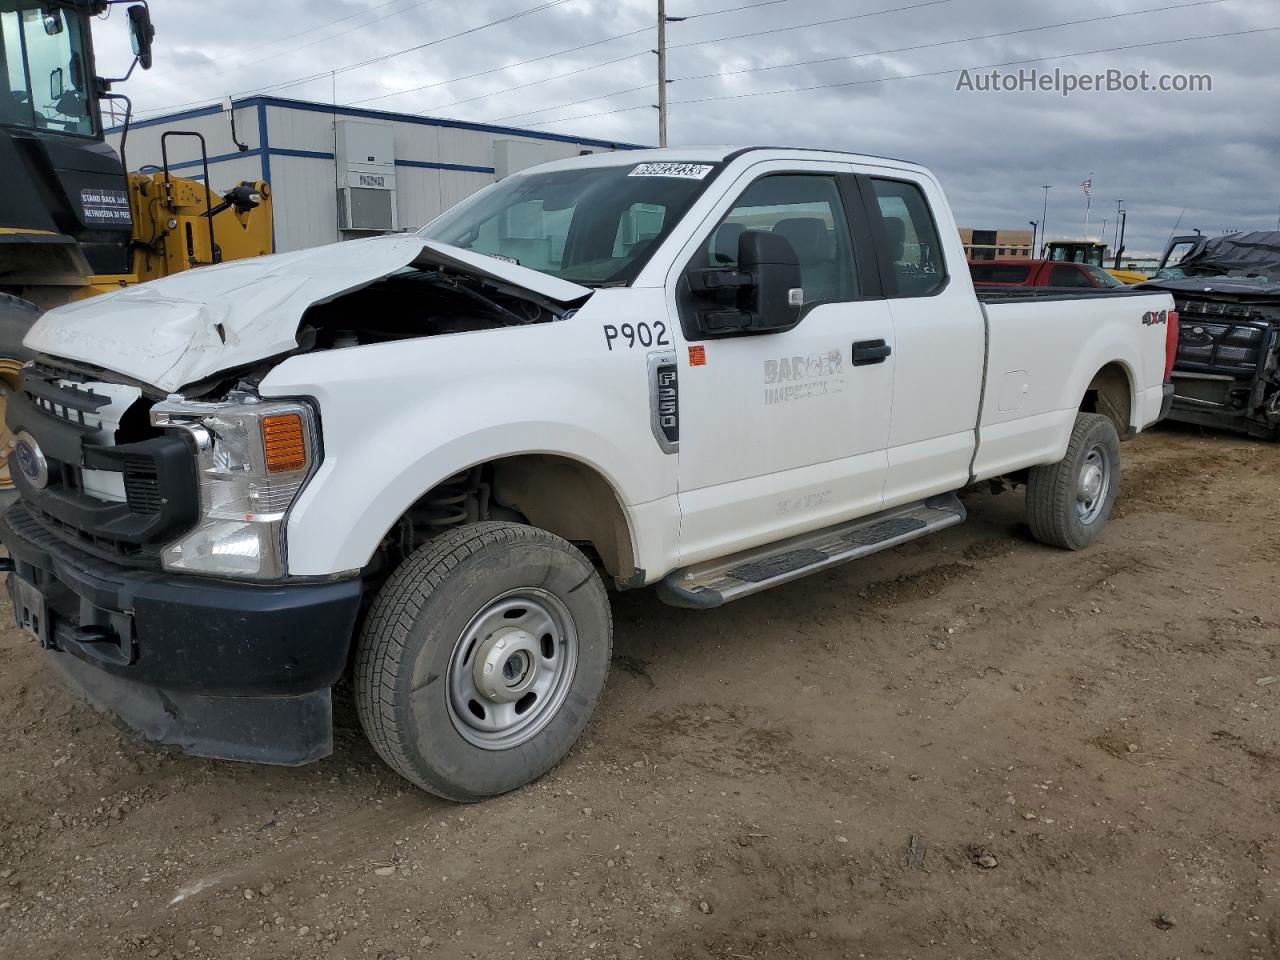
671 163 895 564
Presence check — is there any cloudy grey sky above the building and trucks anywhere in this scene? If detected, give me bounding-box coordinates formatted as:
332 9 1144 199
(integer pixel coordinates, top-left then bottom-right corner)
96 0 1280 252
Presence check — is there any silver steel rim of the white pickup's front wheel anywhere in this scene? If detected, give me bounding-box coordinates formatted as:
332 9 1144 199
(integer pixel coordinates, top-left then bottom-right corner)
448 588 577 750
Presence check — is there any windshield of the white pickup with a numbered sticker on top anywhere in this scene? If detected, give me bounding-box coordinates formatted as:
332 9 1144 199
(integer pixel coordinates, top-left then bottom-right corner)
419 163 716 287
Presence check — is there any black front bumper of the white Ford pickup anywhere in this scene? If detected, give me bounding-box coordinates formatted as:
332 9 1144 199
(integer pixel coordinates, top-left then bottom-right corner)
0 503 361 764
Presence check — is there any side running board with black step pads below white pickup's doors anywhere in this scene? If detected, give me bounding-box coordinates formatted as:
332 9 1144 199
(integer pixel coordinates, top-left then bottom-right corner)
658 493 965 609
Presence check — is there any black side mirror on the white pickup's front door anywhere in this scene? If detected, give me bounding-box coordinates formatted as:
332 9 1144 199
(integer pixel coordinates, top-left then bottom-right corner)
689 230 804 337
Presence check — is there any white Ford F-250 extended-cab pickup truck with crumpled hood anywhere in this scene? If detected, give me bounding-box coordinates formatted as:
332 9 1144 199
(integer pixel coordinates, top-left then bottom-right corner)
0 147 1178 800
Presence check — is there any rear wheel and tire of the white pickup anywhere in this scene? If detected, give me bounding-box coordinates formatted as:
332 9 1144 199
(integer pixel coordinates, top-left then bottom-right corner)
1027 413 1120 550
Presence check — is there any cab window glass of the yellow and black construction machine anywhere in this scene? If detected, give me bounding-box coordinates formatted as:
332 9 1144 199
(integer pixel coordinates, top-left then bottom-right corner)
0 0 93 136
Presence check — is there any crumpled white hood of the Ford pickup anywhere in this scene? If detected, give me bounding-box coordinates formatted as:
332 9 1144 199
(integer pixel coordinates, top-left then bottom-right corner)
23 234 591 393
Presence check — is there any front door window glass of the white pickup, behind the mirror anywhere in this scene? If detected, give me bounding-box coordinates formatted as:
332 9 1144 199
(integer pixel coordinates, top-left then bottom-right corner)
703 173 859 305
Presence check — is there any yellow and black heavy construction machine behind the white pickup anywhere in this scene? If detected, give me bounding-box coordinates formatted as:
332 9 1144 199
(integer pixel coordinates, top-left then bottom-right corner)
0 0 271 509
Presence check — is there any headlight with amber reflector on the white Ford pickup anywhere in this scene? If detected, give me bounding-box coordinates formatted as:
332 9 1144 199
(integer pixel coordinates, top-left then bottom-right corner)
151 396 319 580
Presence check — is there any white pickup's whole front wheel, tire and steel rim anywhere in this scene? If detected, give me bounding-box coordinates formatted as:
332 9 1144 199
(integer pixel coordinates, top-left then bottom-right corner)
355 522 613 803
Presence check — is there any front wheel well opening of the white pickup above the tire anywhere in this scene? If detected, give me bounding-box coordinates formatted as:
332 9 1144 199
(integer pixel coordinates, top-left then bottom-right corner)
366 453 636 581
